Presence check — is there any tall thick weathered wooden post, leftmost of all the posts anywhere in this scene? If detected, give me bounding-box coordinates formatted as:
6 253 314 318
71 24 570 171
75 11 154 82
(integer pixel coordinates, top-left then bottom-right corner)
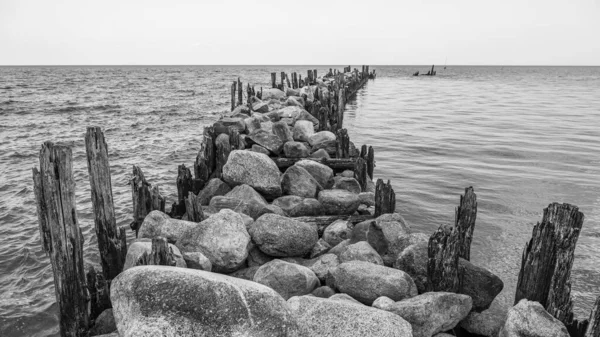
33 142 90 337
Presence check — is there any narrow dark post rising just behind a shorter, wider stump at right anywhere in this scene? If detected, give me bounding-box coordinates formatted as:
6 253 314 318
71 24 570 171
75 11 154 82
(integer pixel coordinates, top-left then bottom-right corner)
454 186 477 261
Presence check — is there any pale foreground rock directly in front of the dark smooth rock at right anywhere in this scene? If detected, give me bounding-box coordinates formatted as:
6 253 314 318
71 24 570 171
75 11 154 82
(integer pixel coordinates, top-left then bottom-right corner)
387 292 472 337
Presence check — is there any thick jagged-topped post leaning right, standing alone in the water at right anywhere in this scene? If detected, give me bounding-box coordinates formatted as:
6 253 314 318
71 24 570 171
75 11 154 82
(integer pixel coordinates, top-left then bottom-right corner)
515 203 584 325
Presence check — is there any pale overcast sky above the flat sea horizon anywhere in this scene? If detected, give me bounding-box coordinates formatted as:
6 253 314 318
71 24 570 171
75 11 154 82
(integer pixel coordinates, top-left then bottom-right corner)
0 0 600 65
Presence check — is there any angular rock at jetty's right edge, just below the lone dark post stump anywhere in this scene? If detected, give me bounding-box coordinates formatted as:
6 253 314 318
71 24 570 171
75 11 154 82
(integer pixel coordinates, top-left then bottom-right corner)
351 213 410 266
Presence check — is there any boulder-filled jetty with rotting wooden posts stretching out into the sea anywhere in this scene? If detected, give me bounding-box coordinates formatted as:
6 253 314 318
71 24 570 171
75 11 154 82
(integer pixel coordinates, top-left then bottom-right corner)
33 66 600 337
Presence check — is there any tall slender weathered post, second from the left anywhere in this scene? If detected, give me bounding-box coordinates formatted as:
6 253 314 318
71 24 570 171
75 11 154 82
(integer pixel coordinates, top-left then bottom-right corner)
85 127 127 282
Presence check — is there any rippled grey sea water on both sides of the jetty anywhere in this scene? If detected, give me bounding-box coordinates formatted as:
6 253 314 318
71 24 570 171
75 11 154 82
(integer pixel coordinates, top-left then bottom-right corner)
0 66 600 336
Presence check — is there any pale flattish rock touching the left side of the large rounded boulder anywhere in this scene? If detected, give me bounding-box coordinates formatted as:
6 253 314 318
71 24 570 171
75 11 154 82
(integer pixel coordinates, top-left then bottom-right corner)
138 211 198 243
